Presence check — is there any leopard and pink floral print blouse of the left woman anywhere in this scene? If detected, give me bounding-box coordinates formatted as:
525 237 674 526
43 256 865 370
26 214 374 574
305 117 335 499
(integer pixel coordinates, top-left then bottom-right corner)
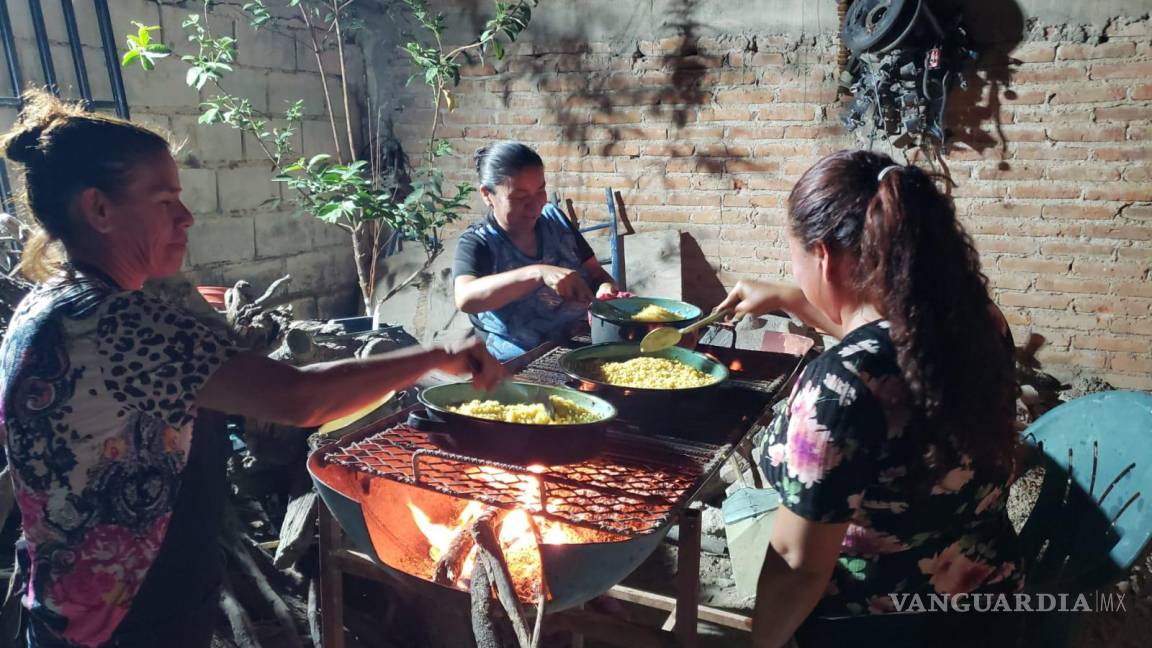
0 269 236 646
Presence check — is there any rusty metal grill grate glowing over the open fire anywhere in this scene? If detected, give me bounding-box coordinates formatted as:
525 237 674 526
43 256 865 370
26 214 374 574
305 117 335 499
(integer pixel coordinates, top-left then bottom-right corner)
321 347 797 536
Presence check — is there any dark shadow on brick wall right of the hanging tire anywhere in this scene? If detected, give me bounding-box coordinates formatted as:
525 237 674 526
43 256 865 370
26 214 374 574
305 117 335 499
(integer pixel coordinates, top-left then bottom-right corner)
945 0 1025 162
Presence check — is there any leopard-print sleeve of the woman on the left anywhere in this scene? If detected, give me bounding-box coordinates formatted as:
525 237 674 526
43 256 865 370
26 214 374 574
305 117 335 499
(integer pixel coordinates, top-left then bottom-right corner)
96 292 240 428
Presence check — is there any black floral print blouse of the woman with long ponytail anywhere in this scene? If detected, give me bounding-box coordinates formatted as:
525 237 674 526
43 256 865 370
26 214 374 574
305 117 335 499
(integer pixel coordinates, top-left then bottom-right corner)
763 321 1023 617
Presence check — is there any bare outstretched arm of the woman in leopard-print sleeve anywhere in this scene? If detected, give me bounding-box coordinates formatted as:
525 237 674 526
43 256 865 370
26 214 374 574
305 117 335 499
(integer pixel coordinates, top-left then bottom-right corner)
196 340 506 428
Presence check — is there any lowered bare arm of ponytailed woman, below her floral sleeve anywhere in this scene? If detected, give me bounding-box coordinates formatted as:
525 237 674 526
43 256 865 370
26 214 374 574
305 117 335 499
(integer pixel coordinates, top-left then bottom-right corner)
752 506 848 648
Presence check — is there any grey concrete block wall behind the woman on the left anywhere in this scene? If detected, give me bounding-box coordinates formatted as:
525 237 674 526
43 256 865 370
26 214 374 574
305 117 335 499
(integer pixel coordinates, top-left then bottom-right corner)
0 0 363 317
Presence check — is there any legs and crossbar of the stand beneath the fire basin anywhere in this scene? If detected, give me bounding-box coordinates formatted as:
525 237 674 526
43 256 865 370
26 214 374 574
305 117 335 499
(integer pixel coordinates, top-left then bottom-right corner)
319 506 752 648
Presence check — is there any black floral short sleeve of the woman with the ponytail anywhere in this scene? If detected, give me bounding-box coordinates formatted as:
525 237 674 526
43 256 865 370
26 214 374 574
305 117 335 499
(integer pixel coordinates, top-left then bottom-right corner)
761 359 886 523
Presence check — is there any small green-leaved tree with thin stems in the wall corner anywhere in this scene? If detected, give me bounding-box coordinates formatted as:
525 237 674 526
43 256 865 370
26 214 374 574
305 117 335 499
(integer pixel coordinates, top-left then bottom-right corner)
121 0 539 312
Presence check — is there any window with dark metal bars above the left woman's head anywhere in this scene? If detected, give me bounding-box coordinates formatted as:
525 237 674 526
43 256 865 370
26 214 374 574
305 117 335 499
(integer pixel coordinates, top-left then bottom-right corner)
0 0 128 206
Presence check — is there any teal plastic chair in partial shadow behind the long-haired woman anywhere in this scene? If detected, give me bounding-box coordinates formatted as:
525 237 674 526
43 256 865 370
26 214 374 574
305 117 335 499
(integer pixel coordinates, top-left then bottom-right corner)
1020 391 1152 646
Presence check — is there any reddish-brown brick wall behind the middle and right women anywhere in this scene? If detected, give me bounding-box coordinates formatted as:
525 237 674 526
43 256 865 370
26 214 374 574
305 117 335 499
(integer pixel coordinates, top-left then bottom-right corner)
373 12 1152 390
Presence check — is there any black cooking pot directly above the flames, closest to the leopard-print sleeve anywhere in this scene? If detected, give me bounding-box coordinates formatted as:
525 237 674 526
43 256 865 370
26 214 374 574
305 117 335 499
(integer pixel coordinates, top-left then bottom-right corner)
408 383 616 466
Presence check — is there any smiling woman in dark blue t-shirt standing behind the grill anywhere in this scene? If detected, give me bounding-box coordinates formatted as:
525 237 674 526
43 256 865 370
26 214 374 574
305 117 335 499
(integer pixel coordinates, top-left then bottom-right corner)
453 142 616 361
